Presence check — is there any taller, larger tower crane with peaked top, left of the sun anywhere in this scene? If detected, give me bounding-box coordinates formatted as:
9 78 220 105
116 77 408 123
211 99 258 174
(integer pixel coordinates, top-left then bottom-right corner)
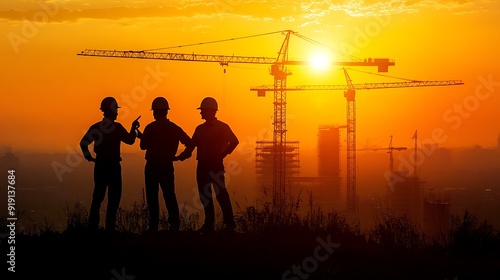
77 30 395 210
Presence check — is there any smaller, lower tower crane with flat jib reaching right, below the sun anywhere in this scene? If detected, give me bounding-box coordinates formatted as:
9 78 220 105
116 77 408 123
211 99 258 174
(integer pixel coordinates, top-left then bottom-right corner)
250 68 464 213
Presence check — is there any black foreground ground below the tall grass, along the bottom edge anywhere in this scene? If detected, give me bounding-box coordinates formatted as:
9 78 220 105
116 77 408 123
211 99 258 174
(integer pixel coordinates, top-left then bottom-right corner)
2 230 500 280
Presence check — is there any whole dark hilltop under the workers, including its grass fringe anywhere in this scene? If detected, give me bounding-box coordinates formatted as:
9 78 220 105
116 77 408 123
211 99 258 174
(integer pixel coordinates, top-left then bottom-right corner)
1 199 500 280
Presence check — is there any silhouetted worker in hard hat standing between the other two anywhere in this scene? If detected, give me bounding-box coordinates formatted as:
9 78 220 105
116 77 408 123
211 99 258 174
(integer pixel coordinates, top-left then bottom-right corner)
137 97 194 231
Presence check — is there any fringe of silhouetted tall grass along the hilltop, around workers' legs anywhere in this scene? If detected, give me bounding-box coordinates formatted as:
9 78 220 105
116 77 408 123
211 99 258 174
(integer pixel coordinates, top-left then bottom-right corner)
6 192 500 256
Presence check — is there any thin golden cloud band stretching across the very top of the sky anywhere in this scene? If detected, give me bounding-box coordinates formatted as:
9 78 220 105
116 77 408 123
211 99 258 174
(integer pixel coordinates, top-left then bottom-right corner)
0 0 499 22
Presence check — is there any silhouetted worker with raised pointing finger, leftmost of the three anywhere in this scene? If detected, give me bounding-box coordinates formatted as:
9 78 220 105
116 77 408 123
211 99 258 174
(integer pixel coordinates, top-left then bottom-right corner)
80 97 140 230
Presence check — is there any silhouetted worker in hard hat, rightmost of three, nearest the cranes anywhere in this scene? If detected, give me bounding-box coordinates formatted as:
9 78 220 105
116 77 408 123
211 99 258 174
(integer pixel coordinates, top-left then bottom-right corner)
193 97 239 233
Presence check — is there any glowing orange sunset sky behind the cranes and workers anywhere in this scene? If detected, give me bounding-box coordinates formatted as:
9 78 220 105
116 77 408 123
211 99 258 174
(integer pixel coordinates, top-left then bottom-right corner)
0 0 500 155
